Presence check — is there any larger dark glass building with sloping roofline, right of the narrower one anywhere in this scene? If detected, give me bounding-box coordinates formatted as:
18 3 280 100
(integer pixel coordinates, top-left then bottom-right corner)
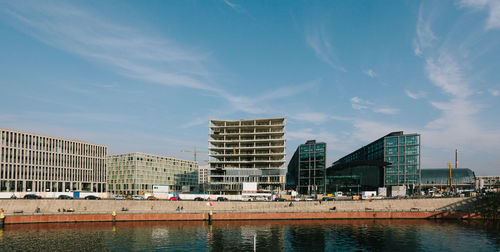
327 131 420 192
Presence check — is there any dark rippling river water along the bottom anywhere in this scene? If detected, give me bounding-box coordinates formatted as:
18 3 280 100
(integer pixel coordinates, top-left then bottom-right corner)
0 220 500 252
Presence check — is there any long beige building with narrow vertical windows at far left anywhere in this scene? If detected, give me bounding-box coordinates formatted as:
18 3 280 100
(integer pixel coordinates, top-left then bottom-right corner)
0 129 108 192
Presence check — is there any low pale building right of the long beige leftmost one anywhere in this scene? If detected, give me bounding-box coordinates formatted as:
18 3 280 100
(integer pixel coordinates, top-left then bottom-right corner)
107 152 198 195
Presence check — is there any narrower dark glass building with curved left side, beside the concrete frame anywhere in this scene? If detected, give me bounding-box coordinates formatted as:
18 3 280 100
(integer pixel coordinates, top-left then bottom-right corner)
287 140 326 195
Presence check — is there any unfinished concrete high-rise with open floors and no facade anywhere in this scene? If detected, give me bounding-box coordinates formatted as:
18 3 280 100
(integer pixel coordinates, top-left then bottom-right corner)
208 118 286 194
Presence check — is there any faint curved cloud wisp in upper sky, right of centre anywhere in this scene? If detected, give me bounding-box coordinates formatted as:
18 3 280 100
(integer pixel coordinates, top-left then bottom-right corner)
306 24 346 72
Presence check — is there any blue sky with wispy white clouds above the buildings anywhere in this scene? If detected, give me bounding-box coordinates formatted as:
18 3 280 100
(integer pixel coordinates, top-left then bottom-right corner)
0 0 500 175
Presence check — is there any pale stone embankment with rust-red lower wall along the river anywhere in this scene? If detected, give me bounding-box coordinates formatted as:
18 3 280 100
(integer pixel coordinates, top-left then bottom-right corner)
0 198 486 224
